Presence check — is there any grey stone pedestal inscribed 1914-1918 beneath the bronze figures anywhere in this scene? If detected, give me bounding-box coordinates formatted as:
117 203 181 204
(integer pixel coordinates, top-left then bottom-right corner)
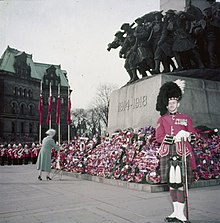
108 70 220 133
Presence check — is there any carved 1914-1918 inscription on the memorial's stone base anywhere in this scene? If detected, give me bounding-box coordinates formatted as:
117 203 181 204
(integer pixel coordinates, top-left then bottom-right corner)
118 95 147 112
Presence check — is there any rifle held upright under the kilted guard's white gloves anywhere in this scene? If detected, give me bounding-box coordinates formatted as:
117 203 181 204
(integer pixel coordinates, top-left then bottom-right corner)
181 137 189 221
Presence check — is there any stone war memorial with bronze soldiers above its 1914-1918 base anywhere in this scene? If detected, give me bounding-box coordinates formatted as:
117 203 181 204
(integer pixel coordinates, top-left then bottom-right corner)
107 0 220 133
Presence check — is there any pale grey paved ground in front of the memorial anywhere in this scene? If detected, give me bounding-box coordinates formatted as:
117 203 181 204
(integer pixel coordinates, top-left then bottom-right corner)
0 164 220 223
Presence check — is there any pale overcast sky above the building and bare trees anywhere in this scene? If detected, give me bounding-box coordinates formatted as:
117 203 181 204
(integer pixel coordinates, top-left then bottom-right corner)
0 0 159 108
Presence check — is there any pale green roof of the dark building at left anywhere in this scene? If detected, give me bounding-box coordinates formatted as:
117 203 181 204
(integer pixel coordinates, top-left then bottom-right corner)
0 46 68 86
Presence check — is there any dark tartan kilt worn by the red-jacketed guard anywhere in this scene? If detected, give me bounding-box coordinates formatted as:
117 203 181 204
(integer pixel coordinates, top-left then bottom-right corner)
160 144 194 184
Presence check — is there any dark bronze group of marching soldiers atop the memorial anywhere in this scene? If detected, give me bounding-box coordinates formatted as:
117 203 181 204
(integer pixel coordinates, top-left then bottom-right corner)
107 0 220 83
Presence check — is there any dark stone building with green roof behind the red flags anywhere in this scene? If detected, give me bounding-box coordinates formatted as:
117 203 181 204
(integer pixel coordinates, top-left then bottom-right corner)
0 46 68 143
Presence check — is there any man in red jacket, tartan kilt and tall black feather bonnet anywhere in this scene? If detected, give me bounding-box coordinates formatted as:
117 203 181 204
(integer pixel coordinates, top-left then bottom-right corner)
156 80 196 223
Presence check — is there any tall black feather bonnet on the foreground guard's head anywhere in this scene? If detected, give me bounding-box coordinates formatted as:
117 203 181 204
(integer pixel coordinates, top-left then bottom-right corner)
156 81 182 115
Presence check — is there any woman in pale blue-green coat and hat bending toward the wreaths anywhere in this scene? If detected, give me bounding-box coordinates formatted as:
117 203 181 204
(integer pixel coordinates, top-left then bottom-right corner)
37 129 60 180
